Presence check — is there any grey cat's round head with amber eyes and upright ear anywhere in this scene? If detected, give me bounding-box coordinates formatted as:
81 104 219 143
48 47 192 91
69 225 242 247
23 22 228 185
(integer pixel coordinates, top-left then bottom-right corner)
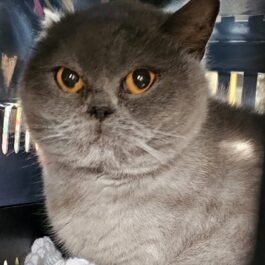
20 0 219 174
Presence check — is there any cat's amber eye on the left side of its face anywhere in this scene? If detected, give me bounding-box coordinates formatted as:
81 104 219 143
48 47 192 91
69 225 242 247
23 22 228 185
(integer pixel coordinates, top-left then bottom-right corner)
55 66 84 94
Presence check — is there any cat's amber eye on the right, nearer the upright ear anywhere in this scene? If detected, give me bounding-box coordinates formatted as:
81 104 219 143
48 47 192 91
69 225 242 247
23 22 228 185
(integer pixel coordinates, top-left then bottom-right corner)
123 69 156 95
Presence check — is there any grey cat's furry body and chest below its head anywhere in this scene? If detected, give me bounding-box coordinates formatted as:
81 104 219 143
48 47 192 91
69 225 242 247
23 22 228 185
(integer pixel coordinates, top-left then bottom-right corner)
42 102 263 265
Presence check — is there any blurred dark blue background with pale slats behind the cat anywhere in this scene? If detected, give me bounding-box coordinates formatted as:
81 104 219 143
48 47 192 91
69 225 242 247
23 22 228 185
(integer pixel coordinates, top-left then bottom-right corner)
0 0 265 265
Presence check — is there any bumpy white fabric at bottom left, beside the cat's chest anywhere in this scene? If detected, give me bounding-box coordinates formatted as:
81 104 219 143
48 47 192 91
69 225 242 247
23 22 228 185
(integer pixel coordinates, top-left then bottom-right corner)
24 237 95 265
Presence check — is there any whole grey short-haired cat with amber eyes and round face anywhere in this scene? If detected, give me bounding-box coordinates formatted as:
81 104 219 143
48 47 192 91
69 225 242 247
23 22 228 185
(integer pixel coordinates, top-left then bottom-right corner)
19 0 264 265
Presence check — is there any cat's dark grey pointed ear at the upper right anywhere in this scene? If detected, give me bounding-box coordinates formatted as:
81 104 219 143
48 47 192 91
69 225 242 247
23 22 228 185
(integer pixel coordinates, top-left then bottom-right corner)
161 0 220 59
